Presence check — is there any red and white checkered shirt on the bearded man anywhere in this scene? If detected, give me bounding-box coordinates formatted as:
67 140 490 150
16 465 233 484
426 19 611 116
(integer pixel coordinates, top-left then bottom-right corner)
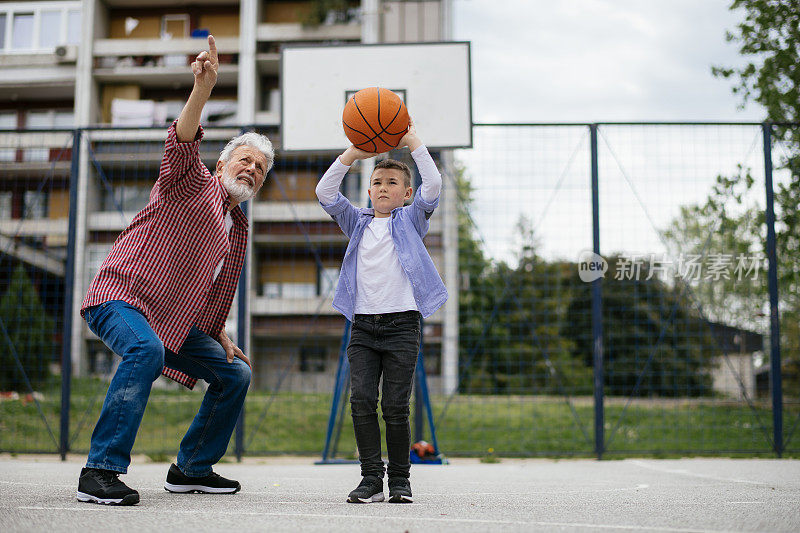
81 121 247 389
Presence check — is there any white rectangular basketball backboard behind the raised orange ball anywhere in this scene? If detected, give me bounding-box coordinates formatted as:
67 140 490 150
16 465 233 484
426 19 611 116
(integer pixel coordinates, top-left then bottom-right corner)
280 42 472 152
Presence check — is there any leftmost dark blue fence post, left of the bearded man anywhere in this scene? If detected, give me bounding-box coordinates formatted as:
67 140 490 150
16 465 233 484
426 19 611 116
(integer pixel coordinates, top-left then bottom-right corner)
58 129 82 461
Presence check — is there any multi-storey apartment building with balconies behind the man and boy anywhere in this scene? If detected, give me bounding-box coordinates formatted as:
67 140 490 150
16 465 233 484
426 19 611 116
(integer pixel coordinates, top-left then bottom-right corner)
0 0 457 391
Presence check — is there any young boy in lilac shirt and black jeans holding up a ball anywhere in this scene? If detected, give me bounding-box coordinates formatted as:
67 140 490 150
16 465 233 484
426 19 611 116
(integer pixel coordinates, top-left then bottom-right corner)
316 118 447 503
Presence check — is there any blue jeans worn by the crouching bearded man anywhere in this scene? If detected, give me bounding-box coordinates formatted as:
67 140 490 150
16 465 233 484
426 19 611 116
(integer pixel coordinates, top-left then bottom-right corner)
84 300 250 476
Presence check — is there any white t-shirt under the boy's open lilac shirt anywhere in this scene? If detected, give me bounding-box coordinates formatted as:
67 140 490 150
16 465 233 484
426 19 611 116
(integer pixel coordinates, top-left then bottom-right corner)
355 217 418 315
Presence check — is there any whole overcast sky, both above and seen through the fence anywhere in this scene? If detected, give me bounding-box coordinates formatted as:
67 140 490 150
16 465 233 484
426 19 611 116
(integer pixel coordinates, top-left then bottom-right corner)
446 0 764 259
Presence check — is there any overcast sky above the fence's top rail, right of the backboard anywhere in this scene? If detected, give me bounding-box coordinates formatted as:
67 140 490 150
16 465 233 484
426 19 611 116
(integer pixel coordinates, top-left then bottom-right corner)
453 0 763 122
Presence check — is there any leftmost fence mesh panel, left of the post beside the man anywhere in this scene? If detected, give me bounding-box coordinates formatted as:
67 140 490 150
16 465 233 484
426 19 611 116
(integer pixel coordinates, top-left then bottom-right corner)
0 130 76 453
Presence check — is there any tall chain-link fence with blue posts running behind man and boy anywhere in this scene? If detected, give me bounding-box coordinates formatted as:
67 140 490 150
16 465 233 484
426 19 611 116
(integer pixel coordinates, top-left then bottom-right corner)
0 123 800 459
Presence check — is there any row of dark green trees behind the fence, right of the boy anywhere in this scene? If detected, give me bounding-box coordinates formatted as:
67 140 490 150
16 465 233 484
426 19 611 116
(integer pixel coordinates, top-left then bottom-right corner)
456 161 719 396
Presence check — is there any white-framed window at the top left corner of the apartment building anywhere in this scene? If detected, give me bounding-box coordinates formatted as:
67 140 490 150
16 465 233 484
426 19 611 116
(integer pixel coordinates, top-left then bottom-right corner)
0 2 81 53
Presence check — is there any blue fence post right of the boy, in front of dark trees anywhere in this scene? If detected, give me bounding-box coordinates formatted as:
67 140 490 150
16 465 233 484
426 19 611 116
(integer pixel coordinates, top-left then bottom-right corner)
589 124 605 459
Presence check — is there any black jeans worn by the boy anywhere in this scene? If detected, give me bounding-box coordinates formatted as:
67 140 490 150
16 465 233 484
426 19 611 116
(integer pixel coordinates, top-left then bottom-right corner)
347 311 420 478
